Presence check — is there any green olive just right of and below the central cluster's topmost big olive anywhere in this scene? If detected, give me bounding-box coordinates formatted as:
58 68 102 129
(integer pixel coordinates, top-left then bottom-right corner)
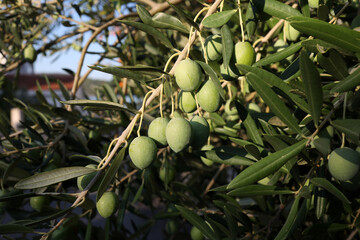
196 80 221 112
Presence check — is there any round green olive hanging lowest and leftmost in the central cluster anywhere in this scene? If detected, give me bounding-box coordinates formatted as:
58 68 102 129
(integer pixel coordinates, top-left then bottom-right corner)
129 136 157 170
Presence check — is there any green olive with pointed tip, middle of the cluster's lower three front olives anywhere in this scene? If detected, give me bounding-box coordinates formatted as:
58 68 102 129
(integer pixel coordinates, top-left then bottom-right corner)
166 117 191 153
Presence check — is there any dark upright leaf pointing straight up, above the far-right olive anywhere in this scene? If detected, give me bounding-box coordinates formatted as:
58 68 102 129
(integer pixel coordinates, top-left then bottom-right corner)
300 50 323 127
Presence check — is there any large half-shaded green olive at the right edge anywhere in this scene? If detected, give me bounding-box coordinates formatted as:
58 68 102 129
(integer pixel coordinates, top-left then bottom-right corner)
328 147 360 181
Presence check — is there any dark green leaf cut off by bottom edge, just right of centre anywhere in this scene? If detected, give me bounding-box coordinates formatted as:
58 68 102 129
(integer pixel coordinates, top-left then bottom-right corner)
175 205 218 240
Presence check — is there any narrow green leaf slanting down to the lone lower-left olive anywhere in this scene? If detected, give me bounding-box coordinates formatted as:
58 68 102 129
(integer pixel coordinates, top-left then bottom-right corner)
96 147 126 201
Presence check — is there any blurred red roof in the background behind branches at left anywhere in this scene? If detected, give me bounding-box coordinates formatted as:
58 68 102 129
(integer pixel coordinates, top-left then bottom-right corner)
7 74 74 90
